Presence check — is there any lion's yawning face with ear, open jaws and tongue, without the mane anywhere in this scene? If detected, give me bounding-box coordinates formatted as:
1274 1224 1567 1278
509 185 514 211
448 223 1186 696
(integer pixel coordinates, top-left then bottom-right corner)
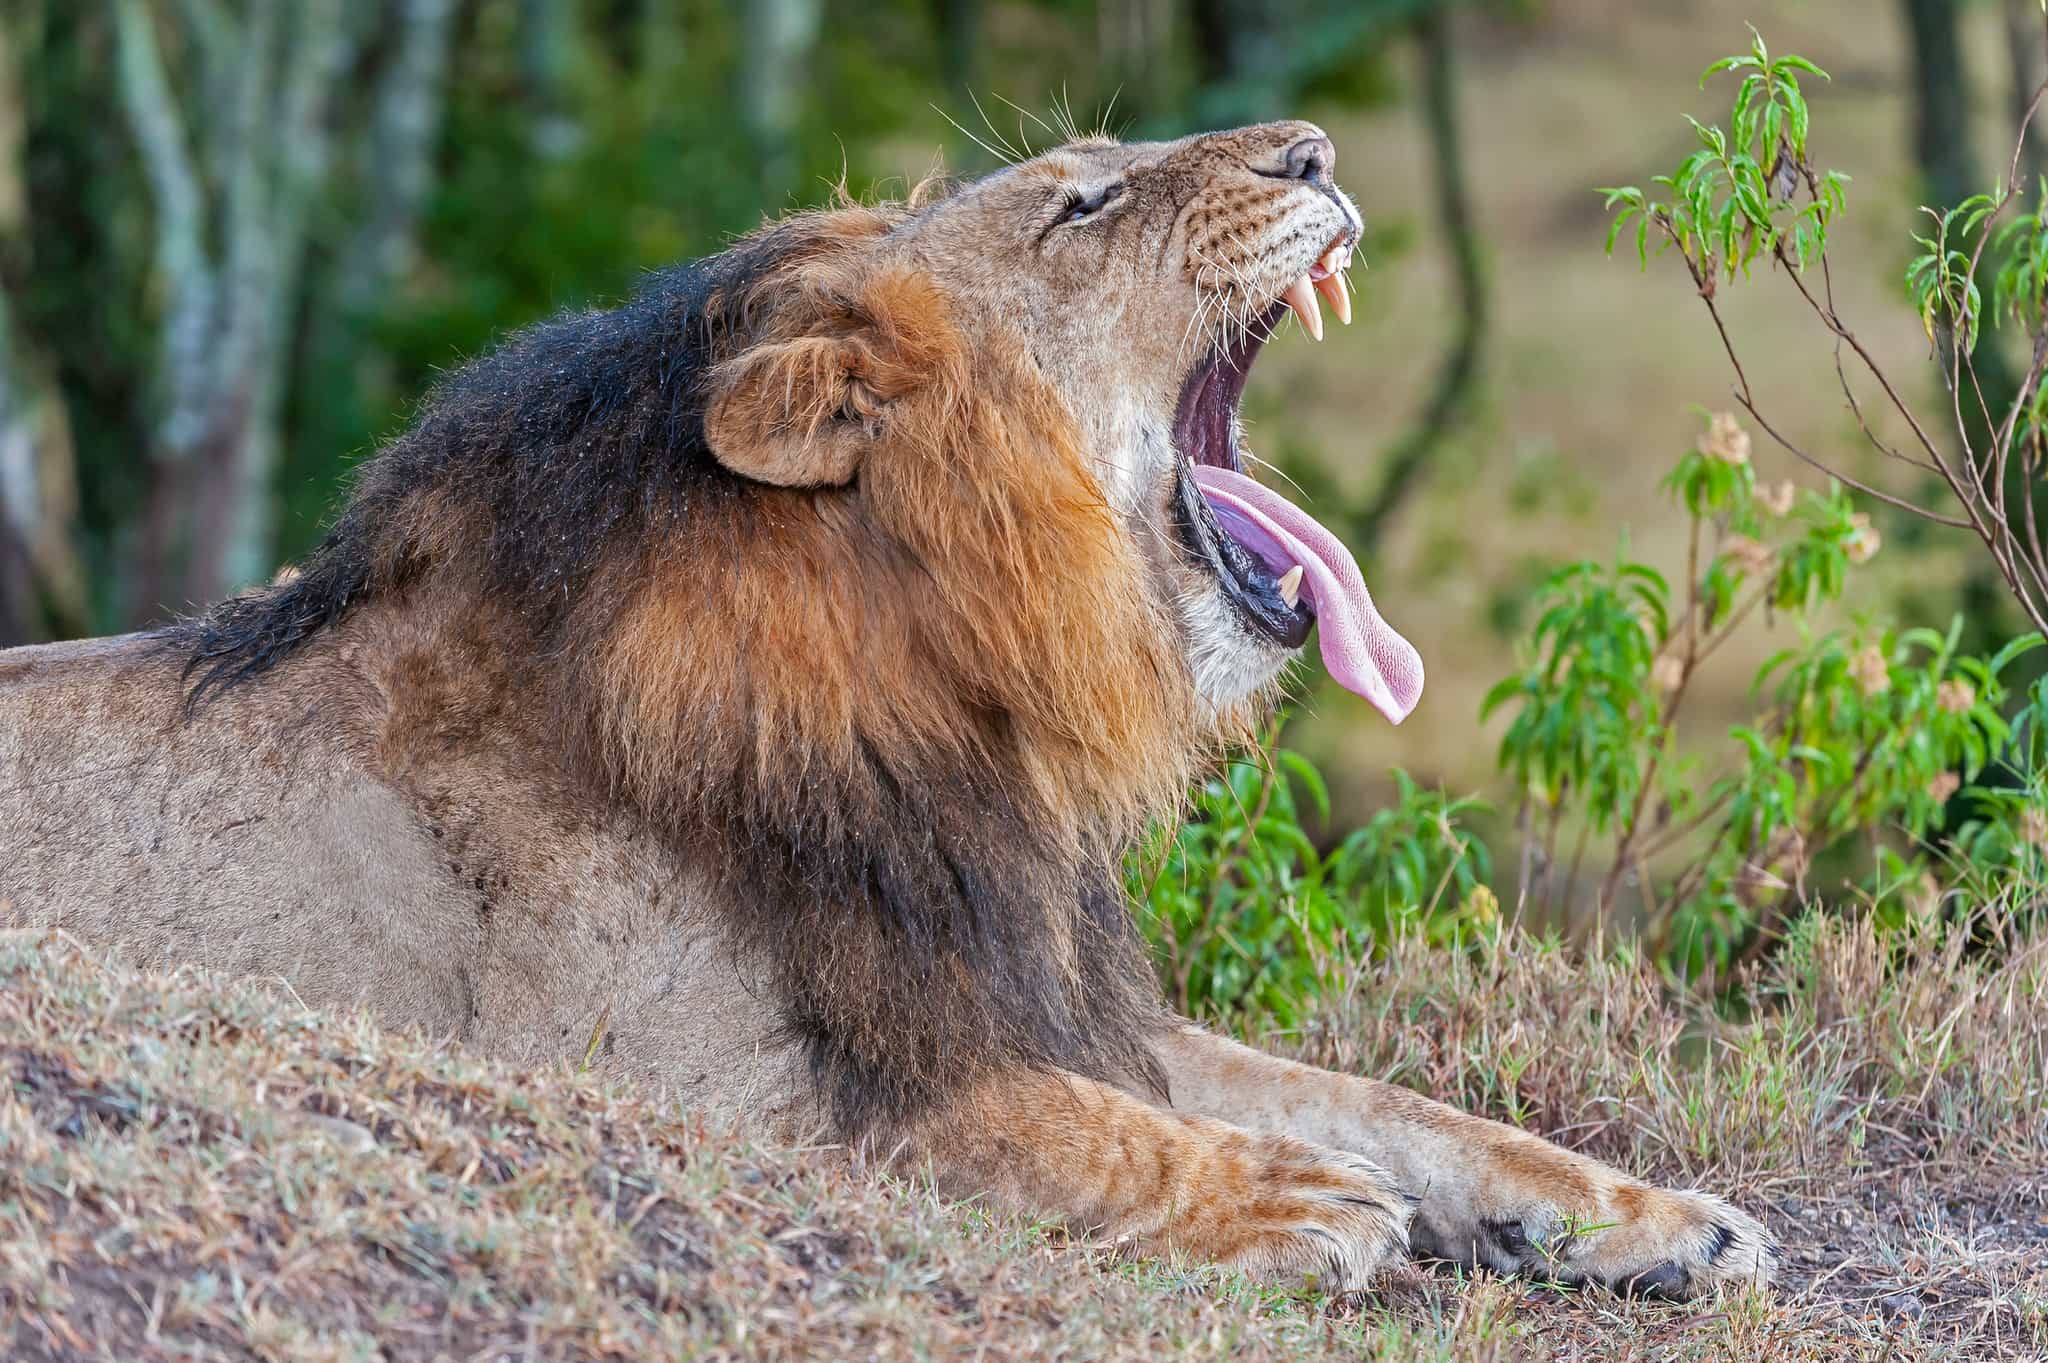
709 123 1421 720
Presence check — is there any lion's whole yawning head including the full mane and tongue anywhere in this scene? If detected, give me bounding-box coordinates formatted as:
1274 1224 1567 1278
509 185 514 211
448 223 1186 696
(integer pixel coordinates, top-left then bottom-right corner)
172 123 1421 1122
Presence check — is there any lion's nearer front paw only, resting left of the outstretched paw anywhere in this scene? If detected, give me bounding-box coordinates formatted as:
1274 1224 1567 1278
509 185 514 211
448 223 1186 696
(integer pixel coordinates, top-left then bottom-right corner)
1165 1136 1415 1293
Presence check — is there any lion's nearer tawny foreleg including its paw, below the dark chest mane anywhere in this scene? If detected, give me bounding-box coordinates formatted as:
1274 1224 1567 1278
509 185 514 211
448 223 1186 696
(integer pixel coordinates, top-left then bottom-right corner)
901 1070 1411 1291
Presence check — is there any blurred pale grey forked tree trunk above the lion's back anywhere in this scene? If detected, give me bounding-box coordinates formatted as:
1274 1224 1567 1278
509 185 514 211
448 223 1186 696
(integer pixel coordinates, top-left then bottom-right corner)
113 0 354 624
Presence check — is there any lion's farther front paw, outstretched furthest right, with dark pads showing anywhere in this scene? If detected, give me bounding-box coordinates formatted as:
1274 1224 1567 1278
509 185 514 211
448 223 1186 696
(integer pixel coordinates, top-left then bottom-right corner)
1454 1181 1780 1298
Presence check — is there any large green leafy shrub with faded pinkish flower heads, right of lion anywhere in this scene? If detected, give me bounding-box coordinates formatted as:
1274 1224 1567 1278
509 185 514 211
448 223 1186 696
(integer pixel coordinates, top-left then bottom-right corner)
1481 415 2040 974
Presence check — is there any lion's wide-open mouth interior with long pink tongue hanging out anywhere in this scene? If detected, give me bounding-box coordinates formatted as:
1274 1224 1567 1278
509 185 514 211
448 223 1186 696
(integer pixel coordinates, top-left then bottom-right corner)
1174 257 1421 724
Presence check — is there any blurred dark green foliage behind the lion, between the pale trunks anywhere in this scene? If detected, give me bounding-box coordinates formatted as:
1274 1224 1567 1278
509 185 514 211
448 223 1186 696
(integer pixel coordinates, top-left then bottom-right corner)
14 0 1456 605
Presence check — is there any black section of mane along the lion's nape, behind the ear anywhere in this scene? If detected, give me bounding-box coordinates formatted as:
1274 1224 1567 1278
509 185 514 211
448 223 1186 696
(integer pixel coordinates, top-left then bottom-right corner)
164 231 784 708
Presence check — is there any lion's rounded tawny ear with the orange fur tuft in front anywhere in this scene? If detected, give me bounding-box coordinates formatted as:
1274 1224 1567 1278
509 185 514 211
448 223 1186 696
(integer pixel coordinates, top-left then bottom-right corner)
705 272 958 487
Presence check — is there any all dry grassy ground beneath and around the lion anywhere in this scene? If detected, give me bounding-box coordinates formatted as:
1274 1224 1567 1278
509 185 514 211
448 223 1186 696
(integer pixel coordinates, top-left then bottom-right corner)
0 900 2048 1363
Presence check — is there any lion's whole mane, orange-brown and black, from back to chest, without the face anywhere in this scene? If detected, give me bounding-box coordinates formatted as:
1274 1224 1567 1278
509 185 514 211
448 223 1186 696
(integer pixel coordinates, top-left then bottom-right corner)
166 205 1200 1130
